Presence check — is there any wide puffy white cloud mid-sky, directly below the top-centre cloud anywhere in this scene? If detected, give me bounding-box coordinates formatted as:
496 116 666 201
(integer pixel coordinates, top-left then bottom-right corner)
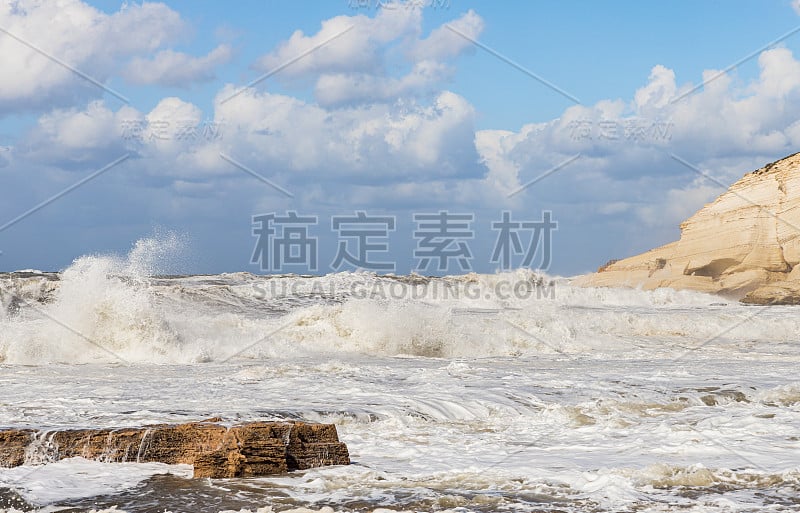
215 85 483 182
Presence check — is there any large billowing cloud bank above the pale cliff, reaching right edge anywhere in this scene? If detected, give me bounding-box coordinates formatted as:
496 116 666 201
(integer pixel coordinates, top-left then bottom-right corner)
466 48 800 250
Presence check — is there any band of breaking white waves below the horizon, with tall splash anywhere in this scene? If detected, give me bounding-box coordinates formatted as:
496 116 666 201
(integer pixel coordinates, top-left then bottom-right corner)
0 237 800 365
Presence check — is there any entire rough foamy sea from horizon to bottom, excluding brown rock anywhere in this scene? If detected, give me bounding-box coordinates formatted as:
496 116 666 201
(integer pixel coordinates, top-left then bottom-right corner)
0 241 800 513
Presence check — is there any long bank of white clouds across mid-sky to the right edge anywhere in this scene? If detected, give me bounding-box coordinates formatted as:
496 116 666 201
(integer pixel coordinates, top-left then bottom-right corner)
23 41 800 224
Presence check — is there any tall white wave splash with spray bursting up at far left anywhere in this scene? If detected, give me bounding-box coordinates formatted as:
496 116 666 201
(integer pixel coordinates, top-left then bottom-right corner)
0 237 186 364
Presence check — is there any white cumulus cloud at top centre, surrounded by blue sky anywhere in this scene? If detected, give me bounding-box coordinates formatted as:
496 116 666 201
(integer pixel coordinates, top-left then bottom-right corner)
253 7 483 106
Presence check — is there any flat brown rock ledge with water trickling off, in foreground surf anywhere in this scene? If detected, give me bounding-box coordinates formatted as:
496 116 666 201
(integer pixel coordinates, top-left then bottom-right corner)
0 422 350 478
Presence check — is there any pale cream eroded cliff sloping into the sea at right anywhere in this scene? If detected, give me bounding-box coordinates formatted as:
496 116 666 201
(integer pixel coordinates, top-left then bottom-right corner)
573 153 800 304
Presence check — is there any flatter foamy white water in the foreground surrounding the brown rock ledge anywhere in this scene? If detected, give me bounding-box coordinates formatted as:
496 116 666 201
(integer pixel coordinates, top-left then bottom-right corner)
0 355 800 512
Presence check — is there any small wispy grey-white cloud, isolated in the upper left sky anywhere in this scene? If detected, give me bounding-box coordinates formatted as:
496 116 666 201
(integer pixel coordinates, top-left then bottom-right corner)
123 44 233 87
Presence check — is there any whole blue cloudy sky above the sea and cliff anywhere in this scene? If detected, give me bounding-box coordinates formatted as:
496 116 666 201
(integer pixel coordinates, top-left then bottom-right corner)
0 0 800 275
